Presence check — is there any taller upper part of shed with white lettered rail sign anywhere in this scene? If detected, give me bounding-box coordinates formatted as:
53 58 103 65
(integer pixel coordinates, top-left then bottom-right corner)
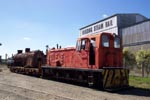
80 14 147 36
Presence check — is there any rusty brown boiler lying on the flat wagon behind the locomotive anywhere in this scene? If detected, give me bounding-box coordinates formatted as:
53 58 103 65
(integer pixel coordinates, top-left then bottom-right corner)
13 49 45 67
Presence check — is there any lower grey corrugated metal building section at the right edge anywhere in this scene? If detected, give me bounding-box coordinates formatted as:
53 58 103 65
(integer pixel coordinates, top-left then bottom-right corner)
122 19 150 51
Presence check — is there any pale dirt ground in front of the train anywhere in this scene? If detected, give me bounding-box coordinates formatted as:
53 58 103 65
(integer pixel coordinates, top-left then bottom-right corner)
0 65 150 100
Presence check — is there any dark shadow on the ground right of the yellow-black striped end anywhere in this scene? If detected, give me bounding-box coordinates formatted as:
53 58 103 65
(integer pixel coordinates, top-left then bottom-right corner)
115 87 150 97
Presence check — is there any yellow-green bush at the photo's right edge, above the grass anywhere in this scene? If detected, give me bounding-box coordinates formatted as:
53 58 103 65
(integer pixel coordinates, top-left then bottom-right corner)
136 50 150 77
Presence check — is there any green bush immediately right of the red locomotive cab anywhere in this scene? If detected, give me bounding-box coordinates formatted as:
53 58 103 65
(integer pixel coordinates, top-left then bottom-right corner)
123 48 136 67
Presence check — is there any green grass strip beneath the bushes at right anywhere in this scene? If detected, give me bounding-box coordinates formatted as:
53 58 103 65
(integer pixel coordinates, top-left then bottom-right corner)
129 76 150 89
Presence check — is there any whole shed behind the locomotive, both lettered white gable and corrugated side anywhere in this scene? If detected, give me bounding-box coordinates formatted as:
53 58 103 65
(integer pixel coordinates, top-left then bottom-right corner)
80 13 150 50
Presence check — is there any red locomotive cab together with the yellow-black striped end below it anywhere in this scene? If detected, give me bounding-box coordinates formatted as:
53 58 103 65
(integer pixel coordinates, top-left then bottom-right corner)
76 33 129 89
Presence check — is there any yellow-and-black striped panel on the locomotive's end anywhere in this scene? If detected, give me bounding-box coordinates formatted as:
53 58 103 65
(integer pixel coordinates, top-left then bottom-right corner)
102 69 129 89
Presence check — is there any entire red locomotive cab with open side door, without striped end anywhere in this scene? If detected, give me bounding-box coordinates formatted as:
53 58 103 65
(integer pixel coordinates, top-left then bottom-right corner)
76 33 123 69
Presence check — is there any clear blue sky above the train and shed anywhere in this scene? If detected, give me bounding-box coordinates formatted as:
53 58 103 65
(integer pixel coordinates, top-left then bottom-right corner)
0 0 150 58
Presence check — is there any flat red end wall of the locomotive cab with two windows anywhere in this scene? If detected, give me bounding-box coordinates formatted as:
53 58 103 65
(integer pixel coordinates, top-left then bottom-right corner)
100 34 123 68
